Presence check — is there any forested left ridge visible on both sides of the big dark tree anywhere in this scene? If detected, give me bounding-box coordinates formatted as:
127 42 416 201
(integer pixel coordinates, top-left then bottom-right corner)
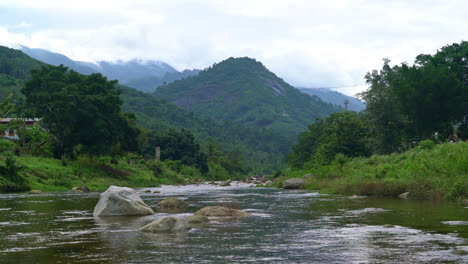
0 46 291 172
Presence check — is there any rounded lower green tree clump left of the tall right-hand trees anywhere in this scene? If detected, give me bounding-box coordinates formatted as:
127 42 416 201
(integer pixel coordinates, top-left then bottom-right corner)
289 111 370 168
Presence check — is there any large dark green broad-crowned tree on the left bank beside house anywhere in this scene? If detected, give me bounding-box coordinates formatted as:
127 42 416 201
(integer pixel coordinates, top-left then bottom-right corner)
22 65 134 157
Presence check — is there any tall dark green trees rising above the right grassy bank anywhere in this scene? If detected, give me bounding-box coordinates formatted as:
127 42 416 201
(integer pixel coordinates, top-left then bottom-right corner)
362 41 468 153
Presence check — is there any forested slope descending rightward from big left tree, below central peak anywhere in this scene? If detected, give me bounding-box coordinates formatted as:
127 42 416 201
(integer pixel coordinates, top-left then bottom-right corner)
119 86 291 172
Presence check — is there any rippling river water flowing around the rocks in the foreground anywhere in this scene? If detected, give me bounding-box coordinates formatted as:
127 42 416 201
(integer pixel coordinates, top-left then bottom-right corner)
0 184 468 263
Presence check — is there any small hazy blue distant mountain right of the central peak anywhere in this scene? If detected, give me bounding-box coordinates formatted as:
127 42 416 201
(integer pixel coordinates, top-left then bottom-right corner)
298 88 366 112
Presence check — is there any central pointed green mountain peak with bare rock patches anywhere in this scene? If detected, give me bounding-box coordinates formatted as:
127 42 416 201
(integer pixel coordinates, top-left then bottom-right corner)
155 57 343 142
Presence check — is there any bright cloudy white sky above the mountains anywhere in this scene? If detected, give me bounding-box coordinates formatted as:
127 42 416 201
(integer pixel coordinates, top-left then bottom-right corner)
0 0 468 95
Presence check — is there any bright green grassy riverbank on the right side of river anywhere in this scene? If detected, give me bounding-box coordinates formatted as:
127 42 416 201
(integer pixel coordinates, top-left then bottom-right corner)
275 142 468 201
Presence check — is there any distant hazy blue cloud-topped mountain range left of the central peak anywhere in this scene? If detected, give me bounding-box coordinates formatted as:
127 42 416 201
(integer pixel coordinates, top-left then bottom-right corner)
20 46 199 92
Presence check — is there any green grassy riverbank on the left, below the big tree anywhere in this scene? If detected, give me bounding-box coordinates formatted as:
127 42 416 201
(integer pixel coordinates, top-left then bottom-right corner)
0 155 210 192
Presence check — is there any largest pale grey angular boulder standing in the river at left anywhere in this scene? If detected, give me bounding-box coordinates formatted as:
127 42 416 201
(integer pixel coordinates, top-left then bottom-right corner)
93 186 154 217
